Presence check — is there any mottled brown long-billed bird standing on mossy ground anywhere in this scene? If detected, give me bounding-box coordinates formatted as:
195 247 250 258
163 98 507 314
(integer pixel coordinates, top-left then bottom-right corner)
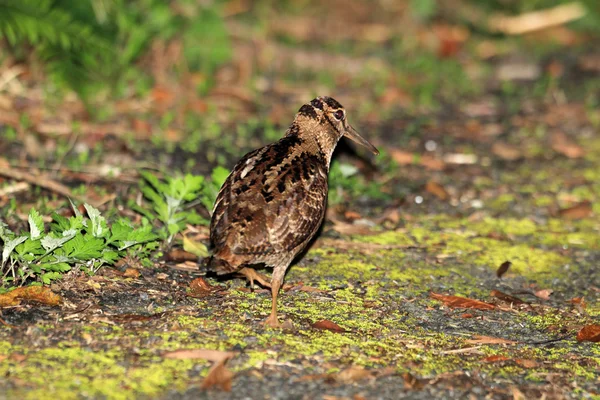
207 97 379 327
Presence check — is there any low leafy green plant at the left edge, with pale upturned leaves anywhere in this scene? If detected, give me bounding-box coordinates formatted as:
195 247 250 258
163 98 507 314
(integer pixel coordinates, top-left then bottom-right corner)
0 204 156 285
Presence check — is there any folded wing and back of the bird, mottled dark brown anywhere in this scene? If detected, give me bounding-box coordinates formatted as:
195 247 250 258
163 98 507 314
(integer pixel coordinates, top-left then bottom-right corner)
211 142 327 256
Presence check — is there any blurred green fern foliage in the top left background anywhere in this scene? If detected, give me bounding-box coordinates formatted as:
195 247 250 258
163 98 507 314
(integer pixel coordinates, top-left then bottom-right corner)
0 0 231 99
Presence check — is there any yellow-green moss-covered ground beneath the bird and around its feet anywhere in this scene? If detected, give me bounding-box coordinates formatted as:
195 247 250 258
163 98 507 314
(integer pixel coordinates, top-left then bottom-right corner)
0 205 600 399
